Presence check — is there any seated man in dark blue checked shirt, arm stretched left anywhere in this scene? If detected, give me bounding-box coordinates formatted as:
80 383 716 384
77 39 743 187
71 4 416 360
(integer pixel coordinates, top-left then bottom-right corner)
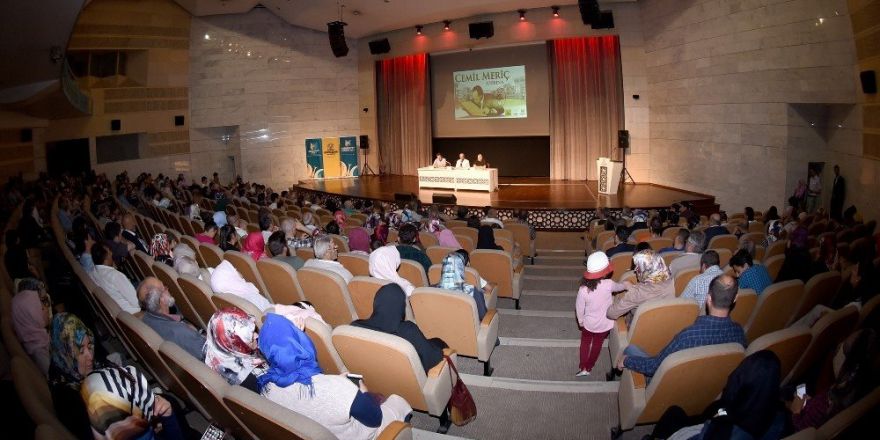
617 275 746 377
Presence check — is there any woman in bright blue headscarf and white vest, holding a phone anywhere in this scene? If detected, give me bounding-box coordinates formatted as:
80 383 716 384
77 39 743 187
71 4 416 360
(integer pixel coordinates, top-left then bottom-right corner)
258 313 412 440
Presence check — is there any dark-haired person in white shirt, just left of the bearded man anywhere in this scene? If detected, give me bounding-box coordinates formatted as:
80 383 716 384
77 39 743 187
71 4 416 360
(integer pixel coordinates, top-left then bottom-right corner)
80 240 141 314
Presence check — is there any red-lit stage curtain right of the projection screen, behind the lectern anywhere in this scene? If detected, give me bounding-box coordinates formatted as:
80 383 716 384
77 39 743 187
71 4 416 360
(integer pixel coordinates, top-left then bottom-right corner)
548 35 623 180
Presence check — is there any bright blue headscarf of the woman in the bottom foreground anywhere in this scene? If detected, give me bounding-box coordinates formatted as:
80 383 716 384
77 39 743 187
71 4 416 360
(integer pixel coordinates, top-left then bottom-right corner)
257 313 321 389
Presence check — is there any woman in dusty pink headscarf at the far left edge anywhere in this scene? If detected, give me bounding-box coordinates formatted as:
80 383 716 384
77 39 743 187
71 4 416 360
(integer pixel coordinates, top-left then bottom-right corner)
12 278 52 376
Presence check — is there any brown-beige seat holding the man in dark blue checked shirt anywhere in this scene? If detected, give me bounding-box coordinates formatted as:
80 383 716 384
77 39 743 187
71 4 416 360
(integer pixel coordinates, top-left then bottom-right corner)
618 343 744 430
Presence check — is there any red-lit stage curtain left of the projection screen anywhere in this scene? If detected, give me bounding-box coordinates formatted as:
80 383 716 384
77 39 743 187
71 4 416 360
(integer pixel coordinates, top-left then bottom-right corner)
376 54 431 175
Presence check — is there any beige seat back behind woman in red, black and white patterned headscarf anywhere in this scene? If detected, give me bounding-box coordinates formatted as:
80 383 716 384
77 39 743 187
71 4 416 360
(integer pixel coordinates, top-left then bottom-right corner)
159 341 254 438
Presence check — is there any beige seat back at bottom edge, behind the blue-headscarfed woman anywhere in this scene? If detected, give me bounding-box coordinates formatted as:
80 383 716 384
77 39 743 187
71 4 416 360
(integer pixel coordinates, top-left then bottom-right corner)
223 386 336 440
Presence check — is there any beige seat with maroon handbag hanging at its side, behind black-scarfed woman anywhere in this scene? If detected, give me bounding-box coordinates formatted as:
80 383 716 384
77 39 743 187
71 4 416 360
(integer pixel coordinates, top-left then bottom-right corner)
333 325 455 422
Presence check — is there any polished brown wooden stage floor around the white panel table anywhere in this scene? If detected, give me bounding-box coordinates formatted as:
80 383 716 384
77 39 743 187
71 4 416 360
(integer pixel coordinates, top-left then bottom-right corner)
297 175 715 210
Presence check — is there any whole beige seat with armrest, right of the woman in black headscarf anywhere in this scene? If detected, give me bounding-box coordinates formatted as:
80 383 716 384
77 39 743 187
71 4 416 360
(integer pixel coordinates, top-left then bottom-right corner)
409 287 499 376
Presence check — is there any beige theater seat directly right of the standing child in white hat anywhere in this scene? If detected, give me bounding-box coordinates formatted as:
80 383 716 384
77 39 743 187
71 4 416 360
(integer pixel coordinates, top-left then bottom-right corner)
608 298 699 364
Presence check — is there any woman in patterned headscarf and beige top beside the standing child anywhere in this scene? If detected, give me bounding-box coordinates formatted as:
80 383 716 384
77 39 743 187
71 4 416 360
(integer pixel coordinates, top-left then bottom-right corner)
607 250 675 319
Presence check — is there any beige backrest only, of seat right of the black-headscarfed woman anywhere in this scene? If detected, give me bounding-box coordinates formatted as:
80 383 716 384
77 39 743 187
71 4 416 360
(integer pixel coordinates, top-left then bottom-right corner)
409 287 480 357
